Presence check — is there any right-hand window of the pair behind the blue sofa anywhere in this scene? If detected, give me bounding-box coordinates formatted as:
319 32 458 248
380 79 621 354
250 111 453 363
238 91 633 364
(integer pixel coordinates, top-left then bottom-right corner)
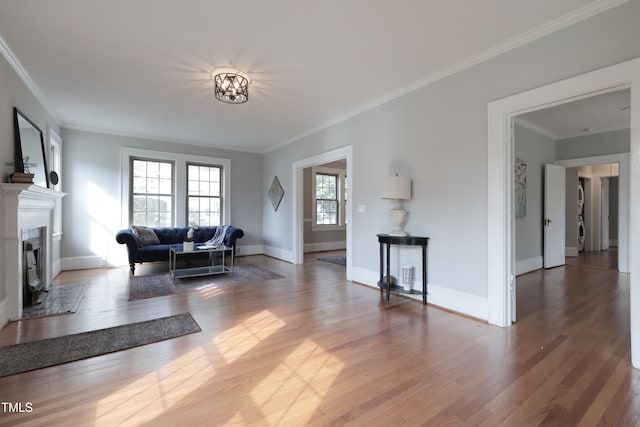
187 163 223 227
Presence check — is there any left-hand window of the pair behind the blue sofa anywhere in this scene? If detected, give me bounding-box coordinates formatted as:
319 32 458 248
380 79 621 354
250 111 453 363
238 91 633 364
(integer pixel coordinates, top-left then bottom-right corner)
129 157 174 227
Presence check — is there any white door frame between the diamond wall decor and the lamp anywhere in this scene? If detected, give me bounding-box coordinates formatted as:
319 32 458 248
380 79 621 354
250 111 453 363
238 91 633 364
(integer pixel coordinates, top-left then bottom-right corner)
291 145 353 280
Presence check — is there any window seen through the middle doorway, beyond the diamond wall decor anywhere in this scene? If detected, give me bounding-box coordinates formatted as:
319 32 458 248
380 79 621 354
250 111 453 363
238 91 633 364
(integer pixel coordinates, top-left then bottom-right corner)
311 166 347 230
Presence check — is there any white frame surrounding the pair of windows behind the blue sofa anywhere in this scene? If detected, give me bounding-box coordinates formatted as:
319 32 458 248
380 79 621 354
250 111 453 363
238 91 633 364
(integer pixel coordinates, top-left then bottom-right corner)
120 147 231 228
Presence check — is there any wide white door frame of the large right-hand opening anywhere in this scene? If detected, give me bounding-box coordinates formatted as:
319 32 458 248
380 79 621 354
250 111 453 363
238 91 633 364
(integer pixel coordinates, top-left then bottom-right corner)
487 58 640 368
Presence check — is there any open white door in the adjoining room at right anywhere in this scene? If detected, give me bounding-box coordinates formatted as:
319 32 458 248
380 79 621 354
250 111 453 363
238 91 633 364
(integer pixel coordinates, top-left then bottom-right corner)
543 164 566 268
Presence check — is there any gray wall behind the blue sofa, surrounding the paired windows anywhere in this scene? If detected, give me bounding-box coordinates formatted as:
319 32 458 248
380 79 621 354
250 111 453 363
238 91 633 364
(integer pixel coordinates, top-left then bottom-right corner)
62 128 266 259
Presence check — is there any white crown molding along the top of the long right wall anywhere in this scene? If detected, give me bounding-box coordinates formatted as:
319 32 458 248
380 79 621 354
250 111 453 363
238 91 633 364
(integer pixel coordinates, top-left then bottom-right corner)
265 0 629 153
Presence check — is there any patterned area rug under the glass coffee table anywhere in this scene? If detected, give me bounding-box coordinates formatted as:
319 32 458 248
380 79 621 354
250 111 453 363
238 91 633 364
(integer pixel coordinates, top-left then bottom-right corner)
129 264 282 301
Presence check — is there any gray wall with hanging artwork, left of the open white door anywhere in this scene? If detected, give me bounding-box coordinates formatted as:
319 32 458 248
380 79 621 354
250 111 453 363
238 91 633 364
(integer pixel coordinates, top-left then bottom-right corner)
514 124 556 262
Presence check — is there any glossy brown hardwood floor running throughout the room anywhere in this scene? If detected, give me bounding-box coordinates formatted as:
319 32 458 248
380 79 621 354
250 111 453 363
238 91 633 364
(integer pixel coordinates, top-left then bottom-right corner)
0 254 640 426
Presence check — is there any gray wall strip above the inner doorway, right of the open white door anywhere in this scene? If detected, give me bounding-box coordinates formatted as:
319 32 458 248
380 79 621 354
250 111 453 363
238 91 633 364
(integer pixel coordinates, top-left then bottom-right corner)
556 129 631 160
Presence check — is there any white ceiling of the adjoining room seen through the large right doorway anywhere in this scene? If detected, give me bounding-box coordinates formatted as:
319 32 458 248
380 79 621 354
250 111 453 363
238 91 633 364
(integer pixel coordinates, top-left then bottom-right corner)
517 89 631 140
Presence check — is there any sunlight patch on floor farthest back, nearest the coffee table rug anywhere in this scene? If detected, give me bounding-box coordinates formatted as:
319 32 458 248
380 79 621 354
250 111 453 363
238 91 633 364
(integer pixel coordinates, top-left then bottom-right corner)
213 310 286 363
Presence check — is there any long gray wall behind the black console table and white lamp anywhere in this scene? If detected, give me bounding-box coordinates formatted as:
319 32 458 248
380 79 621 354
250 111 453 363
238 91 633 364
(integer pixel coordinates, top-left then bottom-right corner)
263 1 640 297
